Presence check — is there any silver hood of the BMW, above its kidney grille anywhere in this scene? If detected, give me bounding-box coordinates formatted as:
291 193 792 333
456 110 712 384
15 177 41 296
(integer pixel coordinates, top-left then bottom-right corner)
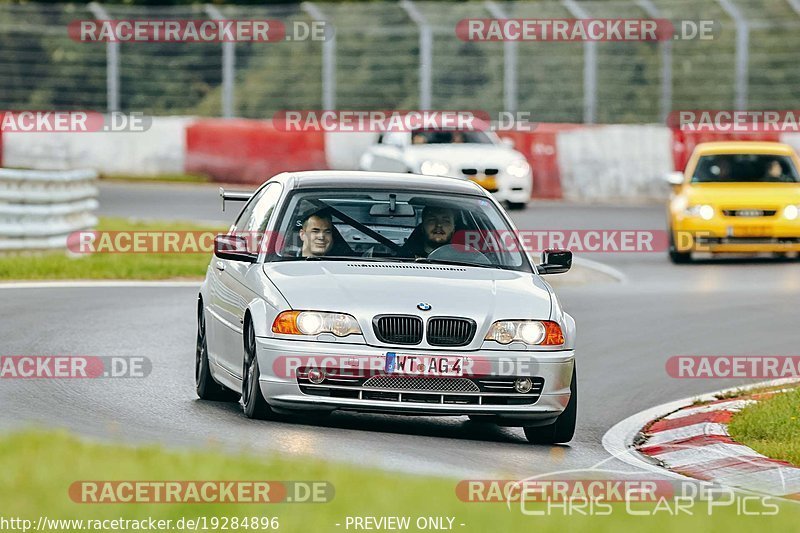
264 261 551 341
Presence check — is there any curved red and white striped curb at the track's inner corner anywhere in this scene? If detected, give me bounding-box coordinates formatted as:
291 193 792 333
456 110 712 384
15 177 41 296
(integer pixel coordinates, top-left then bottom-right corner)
603 379 800 500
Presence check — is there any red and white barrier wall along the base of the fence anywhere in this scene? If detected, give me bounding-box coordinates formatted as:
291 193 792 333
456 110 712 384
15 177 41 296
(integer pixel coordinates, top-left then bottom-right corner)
0 117 800 202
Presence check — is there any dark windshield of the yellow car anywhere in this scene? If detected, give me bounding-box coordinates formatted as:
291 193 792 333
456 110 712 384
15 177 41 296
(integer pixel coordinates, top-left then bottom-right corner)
692 154 800 183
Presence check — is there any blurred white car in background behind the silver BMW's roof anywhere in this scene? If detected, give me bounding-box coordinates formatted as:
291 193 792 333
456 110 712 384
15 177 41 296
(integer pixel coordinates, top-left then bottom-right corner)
359 129 533 209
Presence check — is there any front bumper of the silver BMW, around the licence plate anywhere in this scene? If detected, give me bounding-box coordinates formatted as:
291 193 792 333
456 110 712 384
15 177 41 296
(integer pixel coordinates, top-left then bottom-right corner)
256 338 575 425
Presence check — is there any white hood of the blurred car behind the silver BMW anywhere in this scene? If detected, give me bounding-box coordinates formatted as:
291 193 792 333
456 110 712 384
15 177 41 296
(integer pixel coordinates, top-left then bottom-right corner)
404 144 525 177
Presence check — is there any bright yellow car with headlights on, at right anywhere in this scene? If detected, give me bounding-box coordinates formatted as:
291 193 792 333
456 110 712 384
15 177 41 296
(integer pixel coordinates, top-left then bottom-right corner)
667 141 800 263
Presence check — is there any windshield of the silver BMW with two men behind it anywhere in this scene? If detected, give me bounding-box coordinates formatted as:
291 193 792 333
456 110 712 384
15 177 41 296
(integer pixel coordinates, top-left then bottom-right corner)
270 190 532 272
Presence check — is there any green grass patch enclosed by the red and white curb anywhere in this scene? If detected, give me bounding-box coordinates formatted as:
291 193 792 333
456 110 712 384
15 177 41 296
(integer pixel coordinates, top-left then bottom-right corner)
728 387 800 466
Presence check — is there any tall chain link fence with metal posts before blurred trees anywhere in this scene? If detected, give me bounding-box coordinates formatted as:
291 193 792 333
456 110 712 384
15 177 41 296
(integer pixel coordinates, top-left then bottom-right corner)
0 0 800 123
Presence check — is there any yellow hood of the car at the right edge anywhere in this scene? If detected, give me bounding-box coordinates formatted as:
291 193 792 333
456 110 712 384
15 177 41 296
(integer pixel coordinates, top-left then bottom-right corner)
686 183 800 208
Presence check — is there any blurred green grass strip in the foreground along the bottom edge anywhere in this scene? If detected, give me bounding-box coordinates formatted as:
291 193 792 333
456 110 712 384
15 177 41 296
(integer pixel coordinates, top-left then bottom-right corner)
0 430 800 533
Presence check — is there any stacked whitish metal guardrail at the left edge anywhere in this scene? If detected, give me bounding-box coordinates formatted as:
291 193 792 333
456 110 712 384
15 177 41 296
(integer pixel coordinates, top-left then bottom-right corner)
0 168 98 251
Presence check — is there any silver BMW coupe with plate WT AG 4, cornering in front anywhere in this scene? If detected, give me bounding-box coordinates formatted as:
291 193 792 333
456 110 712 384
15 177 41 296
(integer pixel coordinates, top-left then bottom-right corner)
195 171 577 443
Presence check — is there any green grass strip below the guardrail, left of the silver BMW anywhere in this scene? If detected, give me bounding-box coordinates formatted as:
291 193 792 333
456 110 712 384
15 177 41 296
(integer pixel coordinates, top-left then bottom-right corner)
0 218 227 281
